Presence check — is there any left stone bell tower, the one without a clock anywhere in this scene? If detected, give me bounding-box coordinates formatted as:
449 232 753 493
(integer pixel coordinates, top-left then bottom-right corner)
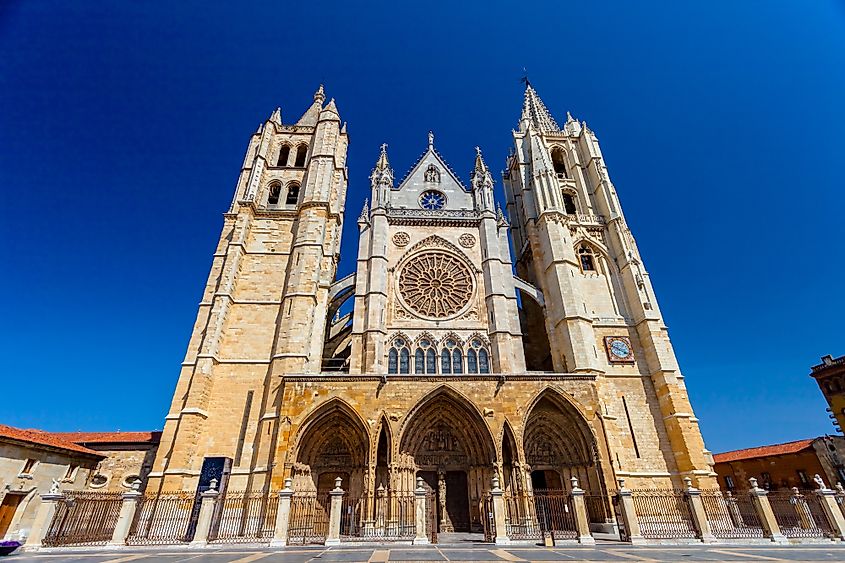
148 86 348 489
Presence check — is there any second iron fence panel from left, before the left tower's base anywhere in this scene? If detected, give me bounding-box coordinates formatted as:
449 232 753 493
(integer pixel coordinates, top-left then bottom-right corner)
126 491 195 545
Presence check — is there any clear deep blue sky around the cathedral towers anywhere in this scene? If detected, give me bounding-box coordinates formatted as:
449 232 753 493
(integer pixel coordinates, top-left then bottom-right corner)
0 0 845 451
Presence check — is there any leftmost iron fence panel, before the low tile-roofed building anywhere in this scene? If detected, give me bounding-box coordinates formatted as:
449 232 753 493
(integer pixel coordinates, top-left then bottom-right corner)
44 491 123 547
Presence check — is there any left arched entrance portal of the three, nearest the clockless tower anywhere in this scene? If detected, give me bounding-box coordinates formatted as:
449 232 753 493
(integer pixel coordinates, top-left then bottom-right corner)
292 400 369 497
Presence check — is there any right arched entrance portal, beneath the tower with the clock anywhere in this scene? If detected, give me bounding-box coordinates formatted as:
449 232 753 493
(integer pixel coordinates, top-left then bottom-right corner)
523 391 604 493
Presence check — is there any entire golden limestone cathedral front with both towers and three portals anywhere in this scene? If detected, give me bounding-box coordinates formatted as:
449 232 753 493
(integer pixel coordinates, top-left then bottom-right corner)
147 86 715 531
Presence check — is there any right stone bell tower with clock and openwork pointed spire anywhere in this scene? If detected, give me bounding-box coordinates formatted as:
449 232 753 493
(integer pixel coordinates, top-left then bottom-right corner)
504 84 713 480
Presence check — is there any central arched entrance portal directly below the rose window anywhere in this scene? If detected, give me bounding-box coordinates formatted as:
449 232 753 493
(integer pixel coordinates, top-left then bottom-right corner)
399 387 496 533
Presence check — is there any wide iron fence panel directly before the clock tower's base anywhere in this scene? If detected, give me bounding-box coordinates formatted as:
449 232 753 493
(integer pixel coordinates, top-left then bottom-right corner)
632 489 697 539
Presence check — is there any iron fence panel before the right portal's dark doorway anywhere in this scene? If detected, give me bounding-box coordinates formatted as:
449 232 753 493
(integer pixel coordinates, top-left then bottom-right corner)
504 489 578 540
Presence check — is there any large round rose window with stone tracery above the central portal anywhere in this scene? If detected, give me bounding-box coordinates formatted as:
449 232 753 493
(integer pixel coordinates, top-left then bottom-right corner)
399 251 472 318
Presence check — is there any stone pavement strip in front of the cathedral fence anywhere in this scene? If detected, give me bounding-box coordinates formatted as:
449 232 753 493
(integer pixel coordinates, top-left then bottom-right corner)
6 543 845 563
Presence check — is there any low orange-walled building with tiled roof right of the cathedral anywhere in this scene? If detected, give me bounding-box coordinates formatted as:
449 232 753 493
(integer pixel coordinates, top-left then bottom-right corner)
713 436 845 491
